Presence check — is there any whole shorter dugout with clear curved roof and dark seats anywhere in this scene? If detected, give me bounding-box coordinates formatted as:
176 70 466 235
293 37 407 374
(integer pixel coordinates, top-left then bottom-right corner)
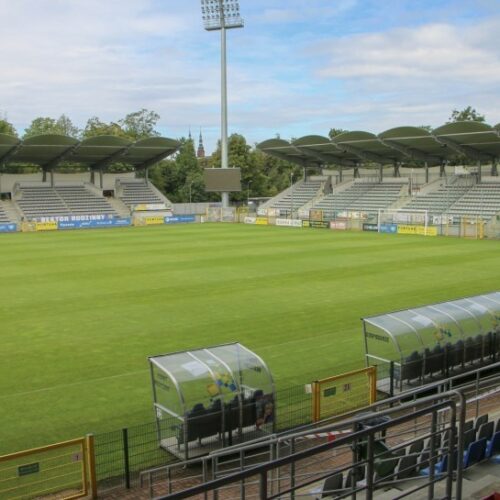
148 343 276 460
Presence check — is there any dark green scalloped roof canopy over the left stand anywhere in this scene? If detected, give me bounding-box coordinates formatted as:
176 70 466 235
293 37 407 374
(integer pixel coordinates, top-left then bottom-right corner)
0 134 180 170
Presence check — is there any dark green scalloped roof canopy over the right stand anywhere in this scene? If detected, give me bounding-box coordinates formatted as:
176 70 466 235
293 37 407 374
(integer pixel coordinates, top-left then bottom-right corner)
257 121 500 167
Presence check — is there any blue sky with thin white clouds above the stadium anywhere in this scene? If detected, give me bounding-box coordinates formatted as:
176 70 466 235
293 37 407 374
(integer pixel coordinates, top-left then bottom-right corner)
0 0 500 153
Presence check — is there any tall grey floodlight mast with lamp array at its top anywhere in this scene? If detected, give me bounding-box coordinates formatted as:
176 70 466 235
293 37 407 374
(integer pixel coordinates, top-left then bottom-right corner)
201 0 243 208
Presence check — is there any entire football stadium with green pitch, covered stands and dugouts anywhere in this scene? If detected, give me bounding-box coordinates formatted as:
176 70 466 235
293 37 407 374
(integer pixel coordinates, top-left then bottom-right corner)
0 0 500 500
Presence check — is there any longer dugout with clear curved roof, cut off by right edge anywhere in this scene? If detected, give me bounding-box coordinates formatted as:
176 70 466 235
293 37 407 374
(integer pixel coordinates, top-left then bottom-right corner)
362 292 500 395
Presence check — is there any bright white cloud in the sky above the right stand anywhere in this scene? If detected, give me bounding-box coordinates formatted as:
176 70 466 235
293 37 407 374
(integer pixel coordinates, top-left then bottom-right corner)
314 20 500 84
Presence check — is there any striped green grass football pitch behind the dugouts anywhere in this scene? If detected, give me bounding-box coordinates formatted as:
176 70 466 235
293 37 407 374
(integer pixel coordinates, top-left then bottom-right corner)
0 224 500 455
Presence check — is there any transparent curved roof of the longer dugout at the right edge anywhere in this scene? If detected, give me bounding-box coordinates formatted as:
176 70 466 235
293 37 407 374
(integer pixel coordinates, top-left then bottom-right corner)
363 292 500 361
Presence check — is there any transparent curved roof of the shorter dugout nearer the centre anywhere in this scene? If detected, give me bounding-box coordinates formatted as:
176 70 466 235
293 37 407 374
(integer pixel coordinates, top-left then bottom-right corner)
149 343 274 417
